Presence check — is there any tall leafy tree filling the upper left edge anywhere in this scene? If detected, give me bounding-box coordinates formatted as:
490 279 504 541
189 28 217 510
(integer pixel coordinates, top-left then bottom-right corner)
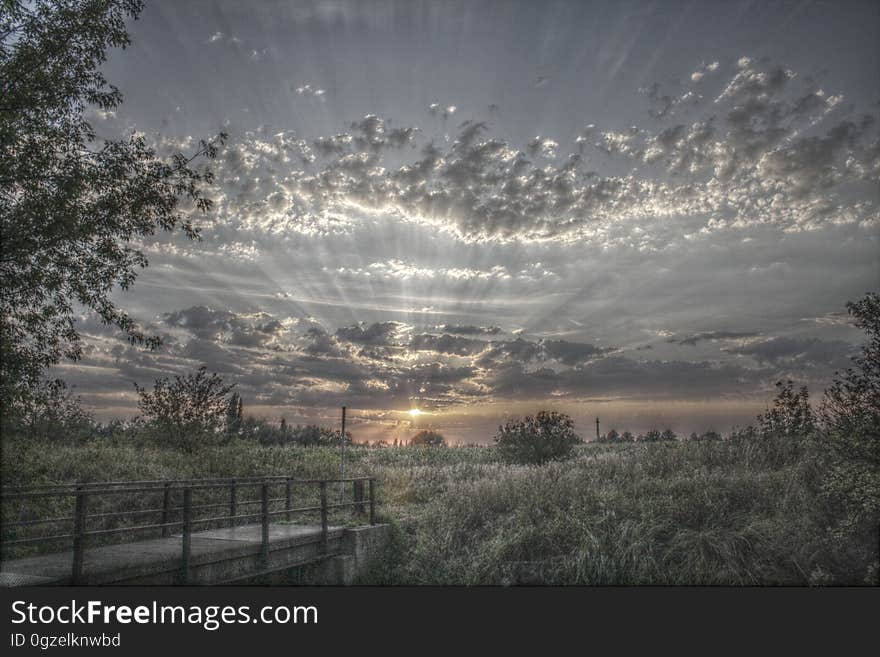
0 0 226 406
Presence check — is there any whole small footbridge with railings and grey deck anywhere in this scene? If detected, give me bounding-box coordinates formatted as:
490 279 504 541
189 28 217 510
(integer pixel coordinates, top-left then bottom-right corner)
0 477 388 586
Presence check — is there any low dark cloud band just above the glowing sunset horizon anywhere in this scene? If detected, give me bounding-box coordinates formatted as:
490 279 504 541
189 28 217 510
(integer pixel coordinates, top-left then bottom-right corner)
70 298 853 418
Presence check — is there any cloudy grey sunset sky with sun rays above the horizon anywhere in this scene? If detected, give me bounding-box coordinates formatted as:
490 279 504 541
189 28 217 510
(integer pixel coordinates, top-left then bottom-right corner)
58 0 880 442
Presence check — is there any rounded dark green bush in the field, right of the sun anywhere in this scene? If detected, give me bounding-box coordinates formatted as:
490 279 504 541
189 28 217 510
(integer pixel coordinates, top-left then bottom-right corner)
494 411 581 465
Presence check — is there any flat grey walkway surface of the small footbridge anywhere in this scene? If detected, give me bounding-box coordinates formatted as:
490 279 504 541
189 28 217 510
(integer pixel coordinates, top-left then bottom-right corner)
0 523 343 587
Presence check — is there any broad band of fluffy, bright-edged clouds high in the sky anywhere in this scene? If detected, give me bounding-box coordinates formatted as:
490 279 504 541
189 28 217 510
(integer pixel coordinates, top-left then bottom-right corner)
196 58 880 246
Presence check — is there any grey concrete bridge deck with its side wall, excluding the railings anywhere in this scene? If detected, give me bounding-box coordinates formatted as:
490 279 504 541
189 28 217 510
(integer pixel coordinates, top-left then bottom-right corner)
0 523 388 587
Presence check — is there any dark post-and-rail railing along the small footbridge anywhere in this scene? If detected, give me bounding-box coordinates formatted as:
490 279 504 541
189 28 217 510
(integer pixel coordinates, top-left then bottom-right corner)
0 476 376 584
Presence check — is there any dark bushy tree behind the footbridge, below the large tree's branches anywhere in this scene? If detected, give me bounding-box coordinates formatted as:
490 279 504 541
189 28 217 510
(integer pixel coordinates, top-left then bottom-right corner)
135 366 235 453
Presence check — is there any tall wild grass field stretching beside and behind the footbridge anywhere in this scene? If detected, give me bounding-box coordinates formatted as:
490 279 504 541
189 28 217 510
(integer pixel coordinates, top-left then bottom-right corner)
2 440 877 585
